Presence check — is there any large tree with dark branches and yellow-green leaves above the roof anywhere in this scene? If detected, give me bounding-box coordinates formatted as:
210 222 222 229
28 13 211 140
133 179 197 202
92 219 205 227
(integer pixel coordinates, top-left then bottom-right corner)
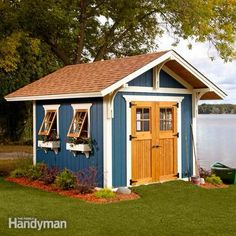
0 0 236 68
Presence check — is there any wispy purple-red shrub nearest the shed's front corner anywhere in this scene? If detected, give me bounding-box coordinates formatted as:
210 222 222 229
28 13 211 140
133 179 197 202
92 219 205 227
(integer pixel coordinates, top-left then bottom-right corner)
76 167 97 194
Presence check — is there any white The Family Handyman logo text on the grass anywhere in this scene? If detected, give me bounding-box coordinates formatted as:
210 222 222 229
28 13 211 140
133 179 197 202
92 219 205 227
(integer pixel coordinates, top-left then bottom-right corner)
8 217 67 230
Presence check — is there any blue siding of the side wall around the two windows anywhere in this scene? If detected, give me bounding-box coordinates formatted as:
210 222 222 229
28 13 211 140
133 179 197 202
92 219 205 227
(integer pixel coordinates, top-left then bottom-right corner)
36 98 103 187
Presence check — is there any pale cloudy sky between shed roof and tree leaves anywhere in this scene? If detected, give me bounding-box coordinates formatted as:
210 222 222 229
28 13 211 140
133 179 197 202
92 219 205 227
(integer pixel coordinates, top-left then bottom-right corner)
157 35 236 104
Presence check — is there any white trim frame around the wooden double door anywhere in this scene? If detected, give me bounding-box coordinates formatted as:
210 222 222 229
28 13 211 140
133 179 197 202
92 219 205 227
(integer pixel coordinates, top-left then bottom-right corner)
123 95 184 186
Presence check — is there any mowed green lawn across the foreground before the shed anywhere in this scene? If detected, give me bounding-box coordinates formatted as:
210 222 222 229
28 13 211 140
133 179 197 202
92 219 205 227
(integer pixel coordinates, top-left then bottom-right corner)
0 178 236 236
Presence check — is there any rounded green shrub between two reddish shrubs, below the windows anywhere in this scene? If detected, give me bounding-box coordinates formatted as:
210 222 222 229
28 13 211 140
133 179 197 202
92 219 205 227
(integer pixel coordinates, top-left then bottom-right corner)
55 169 76 190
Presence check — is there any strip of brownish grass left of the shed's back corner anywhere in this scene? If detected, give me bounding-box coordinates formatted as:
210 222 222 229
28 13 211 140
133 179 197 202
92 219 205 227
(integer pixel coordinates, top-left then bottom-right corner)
0 157 33 176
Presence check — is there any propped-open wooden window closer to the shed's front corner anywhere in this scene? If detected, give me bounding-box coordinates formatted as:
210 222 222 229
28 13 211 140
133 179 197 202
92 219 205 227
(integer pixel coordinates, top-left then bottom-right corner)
67 109 88 138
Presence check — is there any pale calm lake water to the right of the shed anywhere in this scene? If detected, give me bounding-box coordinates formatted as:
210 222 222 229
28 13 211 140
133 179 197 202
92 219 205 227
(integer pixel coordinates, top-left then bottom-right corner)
197 115 236 169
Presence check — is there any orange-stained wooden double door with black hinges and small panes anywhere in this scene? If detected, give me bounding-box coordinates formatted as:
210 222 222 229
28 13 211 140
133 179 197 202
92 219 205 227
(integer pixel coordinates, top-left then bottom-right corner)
130 102 178 184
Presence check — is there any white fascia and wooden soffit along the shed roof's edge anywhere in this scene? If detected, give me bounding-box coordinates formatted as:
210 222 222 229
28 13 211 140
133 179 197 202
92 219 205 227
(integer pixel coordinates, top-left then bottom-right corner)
5 50 227 101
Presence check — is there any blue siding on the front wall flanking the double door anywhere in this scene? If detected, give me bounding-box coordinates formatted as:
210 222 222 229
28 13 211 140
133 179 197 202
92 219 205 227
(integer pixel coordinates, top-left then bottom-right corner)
112 92 192 187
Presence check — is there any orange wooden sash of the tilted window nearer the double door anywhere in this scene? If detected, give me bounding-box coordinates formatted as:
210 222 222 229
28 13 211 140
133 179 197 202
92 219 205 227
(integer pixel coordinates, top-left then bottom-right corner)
67 109 88 138
